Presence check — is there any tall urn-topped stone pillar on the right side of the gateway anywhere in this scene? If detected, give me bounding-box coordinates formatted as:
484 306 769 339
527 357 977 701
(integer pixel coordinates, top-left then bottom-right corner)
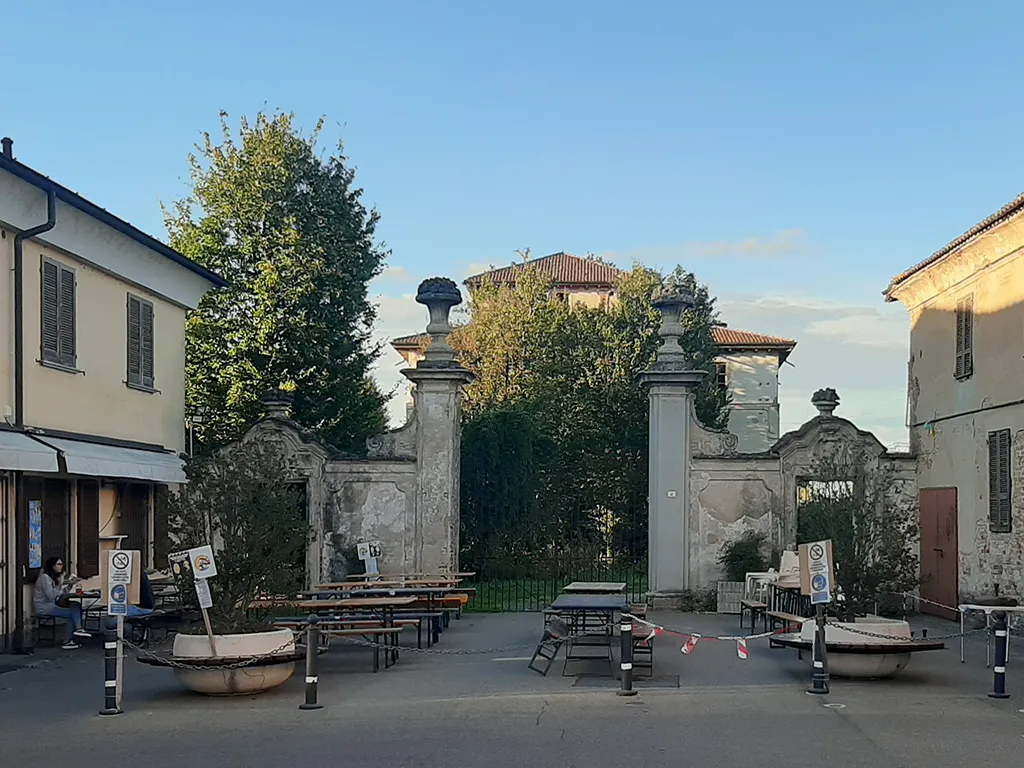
640 281 706 605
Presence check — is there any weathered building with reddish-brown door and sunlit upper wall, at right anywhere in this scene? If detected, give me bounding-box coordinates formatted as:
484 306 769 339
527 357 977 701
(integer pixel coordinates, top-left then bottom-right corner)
886 196 1024 605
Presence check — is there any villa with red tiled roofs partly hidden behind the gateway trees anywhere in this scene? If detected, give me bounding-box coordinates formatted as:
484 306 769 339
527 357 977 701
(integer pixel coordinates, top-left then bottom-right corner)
391 252 797 454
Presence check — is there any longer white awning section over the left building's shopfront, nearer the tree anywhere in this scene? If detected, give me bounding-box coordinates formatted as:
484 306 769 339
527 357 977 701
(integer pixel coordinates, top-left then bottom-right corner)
44 437 188 483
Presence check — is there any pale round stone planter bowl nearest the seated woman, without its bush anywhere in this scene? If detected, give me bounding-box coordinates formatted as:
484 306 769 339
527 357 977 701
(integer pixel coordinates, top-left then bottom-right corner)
173 630 295 696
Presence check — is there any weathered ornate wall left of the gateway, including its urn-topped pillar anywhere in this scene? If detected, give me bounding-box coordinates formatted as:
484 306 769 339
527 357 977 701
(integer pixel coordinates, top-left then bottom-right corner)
235 278 472 584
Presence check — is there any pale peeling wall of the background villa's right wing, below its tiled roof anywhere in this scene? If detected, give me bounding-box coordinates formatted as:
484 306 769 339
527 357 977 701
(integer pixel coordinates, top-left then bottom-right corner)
716 350 779 454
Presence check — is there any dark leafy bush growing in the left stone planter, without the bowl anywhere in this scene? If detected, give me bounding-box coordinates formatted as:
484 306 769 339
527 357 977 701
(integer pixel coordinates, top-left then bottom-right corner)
168 443 309 634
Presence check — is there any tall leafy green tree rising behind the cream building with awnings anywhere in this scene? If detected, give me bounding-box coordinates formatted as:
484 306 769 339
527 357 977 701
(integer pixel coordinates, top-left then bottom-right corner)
165 113 387 449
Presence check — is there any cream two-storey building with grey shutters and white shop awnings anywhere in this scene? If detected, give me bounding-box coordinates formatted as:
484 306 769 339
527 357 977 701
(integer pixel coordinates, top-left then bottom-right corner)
0 140 225 646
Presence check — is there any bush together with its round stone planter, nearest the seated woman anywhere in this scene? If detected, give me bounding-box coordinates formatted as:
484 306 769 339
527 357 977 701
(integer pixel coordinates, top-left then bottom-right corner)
161 442 309 695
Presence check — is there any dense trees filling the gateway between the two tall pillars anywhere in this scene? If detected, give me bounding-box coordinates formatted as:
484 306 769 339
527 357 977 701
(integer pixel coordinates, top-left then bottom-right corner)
452 260 728 567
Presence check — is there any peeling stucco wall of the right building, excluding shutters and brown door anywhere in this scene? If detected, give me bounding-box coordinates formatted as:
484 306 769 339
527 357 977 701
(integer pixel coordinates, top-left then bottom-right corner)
893 216 1024 598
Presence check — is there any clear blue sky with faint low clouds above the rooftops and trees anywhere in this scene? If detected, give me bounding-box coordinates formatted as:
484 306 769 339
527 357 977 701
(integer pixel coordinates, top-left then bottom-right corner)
0 0 1024 442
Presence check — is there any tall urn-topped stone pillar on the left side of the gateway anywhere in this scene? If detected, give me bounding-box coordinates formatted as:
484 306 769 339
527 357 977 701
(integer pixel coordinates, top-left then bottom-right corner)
401 278 473 573
